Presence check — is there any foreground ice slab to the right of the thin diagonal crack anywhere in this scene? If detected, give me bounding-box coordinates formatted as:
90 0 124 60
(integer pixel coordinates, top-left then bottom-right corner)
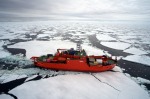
95 72 149 99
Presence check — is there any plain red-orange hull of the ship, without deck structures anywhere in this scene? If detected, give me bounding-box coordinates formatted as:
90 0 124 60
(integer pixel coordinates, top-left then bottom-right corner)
34 59 116 72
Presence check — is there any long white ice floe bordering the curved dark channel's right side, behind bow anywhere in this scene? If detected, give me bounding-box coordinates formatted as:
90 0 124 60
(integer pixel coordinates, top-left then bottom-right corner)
101 42 130 50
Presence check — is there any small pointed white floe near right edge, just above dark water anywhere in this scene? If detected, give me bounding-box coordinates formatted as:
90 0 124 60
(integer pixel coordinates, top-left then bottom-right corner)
123 47 147 55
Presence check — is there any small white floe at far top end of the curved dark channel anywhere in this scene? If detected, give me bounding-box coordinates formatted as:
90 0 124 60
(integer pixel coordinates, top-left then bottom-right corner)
96 34 116 41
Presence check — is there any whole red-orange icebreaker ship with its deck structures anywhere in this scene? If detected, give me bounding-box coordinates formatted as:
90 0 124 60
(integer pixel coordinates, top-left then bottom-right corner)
31 49 117 72
